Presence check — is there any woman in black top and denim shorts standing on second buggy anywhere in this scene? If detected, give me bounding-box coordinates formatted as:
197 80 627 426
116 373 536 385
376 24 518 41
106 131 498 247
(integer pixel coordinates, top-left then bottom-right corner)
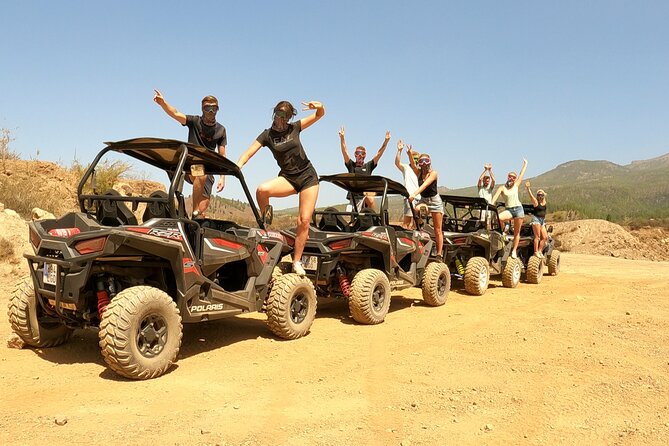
409 147 444 258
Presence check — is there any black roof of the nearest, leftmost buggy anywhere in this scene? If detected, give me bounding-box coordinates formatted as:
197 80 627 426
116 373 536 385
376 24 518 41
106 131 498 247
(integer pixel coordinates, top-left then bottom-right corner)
105 137 241 177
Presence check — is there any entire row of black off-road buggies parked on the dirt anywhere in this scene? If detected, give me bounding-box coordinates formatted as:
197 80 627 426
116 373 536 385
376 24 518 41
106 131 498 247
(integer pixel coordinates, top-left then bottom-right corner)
8 138 560 379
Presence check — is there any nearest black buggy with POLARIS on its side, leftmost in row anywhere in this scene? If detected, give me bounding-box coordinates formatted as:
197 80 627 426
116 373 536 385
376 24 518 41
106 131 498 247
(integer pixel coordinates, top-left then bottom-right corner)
9 138 316 379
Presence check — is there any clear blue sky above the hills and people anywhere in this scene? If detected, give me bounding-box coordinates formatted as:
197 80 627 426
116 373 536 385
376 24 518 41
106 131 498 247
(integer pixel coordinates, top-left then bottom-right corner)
0 0 669 208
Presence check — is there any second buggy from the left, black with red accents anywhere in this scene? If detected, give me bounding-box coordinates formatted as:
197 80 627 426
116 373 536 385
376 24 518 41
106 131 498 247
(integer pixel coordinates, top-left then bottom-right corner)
283 173 450 324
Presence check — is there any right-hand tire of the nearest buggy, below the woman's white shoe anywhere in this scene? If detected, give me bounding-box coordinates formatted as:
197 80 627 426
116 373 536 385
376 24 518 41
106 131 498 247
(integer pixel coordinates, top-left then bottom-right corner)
266 273 316 339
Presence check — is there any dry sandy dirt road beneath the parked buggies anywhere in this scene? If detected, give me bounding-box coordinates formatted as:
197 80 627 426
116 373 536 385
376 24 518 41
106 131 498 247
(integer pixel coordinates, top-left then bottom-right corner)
0 253 669 446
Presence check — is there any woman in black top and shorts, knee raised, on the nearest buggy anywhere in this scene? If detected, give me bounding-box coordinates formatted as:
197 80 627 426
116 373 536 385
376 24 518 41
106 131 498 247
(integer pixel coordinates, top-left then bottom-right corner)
237 101 325 276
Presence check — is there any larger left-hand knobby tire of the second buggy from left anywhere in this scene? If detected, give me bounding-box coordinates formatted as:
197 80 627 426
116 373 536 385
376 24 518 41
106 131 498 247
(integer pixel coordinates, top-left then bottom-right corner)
348 268 390 325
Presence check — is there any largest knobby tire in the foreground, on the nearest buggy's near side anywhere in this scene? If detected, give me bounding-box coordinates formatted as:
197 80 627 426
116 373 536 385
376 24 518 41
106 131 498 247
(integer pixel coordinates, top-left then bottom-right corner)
99 286 183 379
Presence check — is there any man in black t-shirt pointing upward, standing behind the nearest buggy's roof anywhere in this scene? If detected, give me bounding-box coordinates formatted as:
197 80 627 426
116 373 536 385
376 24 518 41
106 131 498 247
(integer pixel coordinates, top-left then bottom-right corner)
153 90 228 218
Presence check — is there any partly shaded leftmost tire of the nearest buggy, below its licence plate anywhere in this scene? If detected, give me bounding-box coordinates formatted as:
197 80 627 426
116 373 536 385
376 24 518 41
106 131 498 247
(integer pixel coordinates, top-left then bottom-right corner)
7 278 74 347
